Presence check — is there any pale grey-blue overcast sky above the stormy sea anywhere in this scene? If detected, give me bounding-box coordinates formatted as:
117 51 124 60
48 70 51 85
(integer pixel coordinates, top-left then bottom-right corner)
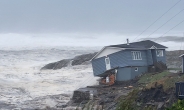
0 0 184 48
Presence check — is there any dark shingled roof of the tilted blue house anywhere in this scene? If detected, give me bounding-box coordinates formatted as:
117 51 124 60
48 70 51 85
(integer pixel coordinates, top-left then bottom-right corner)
107 40 167 49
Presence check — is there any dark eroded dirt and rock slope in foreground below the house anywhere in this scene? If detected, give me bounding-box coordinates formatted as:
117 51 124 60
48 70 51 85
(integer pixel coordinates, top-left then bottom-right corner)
62 73 183 110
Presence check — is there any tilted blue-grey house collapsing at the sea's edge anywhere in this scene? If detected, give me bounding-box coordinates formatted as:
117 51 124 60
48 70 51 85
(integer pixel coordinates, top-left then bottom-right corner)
91 39 167 83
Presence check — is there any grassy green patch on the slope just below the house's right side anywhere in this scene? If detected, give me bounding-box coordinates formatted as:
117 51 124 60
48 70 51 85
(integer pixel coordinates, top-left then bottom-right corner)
138 71 170 84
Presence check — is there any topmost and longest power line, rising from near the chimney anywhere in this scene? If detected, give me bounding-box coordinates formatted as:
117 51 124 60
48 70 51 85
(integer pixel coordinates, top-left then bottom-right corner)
133 0 181 41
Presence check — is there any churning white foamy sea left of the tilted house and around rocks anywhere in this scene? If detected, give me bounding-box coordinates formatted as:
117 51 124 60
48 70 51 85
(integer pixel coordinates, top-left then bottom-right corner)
0 49 97 108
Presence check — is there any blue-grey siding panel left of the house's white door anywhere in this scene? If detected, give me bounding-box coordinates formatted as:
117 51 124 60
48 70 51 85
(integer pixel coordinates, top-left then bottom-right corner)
92 57 106 76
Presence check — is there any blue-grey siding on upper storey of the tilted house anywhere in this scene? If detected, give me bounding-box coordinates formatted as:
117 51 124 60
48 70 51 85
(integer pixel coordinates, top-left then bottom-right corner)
92 50 156 76
